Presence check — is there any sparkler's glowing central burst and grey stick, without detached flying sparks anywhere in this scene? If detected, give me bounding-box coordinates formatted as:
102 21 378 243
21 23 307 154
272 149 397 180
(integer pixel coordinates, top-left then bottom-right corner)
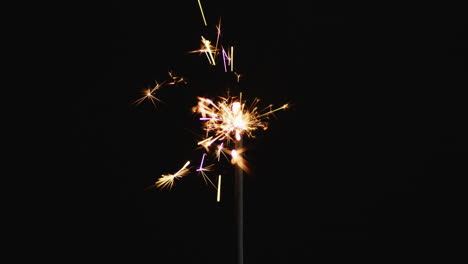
192 93 288 264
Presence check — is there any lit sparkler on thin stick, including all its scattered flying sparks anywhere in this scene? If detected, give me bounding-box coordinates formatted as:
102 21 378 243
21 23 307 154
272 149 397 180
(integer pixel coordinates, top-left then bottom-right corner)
134 0 288 263
